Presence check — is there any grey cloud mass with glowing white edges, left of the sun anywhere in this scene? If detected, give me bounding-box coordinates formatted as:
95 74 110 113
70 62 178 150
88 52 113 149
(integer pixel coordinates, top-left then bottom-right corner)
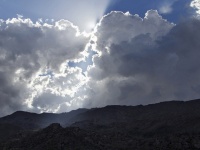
0 17 89 115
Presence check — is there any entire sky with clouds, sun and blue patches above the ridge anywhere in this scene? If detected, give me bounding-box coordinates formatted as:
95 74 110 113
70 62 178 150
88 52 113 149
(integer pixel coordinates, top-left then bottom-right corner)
0 0 200 116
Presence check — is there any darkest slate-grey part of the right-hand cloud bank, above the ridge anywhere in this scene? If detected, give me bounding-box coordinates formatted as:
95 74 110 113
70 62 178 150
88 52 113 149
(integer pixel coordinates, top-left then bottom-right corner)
115 20 200 103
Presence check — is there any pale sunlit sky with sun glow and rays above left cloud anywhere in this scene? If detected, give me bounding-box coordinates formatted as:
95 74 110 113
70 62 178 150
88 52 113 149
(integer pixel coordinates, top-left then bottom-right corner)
13 0 111 32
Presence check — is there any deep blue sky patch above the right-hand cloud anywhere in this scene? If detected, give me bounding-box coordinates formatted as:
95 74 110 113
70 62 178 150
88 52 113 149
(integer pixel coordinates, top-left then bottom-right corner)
106 0 191 23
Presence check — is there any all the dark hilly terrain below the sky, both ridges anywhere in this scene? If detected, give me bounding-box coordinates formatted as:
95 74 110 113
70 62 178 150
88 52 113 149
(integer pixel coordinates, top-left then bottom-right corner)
0 100 200 150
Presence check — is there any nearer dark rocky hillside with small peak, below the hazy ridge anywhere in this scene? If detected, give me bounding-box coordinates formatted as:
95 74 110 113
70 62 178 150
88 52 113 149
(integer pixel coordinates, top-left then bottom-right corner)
0 124 200 150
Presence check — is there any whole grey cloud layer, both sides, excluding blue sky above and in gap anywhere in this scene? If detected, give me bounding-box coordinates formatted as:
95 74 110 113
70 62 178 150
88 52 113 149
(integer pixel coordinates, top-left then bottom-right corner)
0 10 200 116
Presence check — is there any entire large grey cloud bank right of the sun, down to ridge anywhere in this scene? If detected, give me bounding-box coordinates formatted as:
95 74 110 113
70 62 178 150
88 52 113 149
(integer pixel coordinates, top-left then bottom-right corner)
85 10 200 107
